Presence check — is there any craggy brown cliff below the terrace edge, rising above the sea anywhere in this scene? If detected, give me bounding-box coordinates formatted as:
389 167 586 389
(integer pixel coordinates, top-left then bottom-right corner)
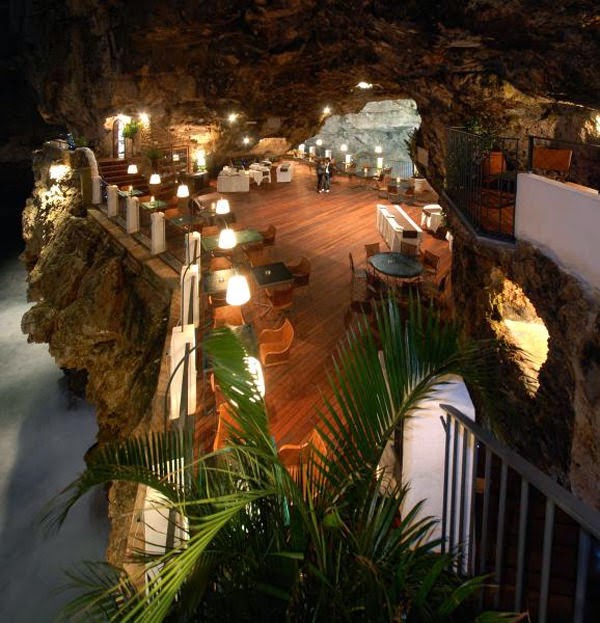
22 148 171 442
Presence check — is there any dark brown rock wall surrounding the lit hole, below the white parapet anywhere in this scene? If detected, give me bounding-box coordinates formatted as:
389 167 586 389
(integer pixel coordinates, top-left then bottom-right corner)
451 212 600 508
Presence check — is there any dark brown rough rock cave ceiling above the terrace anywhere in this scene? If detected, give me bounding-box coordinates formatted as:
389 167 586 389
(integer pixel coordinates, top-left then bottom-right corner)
12 0 600 154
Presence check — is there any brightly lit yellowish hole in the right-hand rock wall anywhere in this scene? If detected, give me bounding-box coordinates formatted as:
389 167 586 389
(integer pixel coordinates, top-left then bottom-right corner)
494 277 550 397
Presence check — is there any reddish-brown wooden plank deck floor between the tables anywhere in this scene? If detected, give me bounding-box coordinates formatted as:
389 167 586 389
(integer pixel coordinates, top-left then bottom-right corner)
197 163 451 448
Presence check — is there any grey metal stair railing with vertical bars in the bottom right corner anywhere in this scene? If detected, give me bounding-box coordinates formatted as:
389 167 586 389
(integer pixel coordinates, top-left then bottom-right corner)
440 404 600 623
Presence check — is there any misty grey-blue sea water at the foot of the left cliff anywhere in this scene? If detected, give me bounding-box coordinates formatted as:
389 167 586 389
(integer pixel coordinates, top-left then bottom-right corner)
0 247 108 623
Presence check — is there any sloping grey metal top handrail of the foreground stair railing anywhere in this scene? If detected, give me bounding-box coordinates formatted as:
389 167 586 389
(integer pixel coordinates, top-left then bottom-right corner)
440 403 600 539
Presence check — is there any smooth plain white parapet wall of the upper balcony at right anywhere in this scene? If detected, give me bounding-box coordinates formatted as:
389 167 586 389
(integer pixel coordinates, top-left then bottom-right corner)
515 173 600 287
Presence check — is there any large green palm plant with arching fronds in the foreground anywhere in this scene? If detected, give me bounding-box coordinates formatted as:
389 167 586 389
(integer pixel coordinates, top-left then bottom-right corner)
48 300 512 622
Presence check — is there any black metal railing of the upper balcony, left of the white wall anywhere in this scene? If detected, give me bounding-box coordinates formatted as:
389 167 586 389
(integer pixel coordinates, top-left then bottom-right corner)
445 128 519 240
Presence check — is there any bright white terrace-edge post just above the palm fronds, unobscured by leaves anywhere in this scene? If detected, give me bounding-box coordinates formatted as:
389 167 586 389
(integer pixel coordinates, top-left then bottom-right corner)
169 324 196 420
